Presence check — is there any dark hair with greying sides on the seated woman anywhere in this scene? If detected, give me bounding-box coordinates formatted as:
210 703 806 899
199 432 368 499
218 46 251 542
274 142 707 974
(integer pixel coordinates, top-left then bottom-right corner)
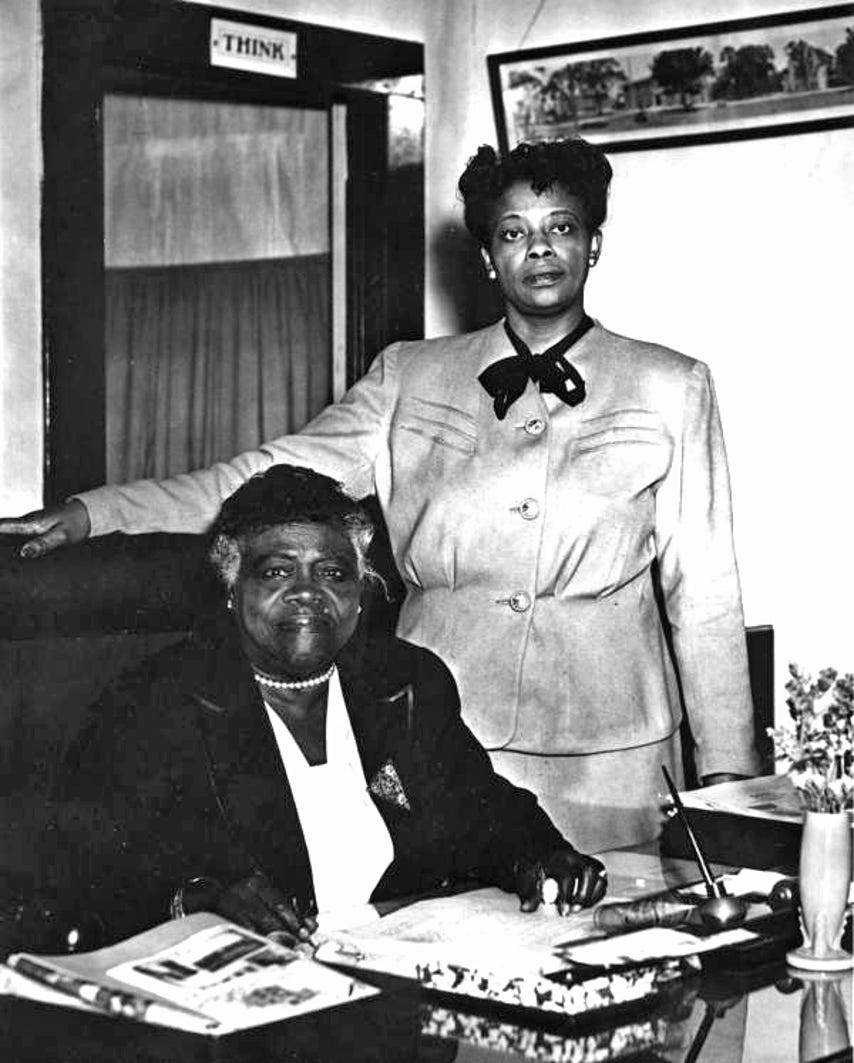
207 465 385 588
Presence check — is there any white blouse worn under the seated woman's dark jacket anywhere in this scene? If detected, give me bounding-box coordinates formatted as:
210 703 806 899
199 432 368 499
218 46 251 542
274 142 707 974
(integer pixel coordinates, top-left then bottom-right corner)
266 671 395 913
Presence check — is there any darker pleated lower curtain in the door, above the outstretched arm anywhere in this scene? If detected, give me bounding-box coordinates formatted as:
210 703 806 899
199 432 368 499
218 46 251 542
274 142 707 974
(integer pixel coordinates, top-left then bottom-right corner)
106 254 331 483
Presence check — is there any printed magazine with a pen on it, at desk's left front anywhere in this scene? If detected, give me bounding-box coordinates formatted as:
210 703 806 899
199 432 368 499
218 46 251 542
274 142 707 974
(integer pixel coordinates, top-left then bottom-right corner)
0 912 378 1036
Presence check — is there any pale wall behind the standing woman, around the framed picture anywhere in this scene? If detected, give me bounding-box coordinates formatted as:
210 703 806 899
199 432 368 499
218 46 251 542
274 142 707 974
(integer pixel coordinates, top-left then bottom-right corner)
426 0 854 707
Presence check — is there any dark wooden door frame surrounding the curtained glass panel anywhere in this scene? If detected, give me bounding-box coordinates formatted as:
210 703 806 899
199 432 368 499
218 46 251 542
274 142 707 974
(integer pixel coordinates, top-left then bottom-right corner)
41 0 423 503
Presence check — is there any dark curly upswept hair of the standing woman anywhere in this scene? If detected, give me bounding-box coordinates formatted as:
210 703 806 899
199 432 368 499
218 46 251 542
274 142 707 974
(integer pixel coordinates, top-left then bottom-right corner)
457 137 614 248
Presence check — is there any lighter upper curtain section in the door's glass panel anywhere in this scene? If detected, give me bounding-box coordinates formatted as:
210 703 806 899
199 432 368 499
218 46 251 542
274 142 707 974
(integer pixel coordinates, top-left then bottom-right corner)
104 96 329 268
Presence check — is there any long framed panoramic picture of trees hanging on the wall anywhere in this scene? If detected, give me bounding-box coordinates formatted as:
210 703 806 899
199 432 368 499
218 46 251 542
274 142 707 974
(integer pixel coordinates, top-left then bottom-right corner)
487 3 854 151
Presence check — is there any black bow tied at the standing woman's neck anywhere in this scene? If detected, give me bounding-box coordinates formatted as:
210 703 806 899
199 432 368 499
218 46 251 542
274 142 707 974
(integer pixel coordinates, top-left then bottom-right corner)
478 314 593 421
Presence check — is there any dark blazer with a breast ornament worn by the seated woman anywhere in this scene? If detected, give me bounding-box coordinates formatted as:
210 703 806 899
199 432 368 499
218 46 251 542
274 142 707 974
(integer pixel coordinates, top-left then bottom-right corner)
44 621 567 940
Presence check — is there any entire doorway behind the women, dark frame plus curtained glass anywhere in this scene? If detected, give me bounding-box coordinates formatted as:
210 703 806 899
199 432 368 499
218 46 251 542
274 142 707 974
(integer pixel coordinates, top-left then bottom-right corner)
43 0 423 502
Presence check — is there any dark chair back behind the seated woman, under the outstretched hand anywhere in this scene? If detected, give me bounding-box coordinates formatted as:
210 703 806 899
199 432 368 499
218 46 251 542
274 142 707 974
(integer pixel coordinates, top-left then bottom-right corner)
0 535 221 793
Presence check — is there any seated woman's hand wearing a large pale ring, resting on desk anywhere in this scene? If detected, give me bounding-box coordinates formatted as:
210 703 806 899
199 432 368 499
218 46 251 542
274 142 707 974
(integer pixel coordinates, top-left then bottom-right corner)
516 847 608 915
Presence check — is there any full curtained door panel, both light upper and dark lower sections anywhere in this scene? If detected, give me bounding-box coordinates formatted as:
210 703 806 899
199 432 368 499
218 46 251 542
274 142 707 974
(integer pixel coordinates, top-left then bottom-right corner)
99 96 332 483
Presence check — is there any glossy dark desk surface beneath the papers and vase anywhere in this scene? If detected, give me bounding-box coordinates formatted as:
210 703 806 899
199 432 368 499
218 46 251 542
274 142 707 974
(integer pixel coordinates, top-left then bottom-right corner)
0 851 852 1063
